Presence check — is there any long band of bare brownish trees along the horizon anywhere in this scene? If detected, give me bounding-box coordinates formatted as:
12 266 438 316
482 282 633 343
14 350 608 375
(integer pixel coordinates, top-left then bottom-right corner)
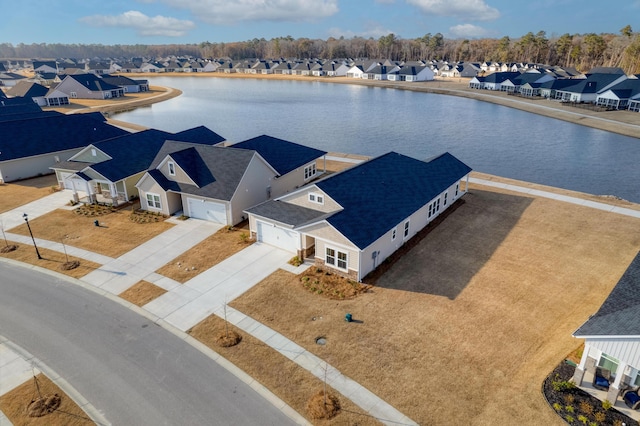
0 25 640 74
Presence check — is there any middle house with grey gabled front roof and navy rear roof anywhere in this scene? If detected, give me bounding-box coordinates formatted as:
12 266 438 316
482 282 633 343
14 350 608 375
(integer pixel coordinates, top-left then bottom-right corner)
136 135 326 225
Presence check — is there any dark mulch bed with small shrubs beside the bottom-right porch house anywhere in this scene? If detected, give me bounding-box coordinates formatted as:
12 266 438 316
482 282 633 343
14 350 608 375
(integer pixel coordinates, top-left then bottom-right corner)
542 362 638 426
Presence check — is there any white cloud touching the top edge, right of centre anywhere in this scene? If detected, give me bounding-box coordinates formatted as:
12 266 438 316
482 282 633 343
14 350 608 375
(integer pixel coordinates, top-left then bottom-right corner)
407 0 500 21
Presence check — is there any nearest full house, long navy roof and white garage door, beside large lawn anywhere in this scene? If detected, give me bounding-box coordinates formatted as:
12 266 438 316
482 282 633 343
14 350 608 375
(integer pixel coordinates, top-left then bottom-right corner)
247 152 471 281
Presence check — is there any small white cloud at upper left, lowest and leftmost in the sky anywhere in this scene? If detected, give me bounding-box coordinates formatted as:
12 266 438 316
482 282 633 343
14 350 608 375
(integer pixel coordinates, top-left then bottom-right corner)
80 10 196 37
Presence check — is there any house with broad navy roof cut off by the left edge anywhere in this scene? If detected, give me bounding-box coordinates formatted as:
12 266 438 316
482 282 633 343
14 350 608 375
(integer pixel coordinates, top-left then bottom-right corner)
0 110 129 182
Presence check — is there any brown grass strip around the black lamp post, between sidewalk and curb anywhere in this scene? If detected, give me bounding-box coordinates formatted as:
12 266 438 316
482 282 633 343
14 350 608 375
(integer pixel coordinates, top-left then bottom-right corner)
0 241 101 278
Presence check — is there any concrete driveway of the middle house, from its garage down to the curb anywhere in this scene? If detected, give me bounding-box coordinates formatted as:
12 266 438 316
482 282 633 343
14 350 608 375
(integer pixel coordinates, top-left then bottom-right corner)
81 219 223 294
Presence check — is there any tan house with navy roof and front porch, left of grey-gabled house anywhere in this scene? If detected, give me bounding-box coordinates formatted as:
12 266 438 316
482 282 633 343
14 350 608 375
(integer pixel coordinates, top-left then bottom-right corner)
51 126 224 204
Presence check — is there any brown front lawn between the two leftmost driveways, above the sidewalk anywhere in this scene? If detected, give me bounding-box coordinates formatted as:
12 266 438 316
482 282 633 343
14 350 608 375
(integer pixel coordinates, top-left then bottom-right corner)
10 209 173 257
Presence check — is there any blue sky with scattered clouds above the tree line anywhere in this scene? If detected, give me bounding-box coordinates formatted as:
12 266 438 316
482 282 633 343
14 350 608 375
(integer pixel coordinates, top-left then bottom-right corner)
5 0 640 46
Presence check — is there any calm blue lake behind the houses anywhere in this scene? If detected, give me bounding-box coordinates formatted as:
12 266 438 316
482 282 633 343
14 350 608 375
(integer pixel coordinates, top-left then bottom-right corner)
114 77 640 202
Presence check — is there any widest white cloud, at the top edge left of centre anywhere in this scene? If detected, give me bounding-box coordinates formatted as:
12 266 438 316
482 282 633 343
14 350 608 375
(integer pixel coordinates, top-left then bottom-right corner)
162 0 338 25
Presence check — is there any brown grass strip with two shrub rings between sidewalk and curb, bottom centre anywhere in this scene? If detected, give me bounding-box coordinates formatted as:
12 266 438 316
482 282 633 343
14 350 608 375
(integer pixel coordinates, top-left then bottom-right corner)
189 315 380 426
